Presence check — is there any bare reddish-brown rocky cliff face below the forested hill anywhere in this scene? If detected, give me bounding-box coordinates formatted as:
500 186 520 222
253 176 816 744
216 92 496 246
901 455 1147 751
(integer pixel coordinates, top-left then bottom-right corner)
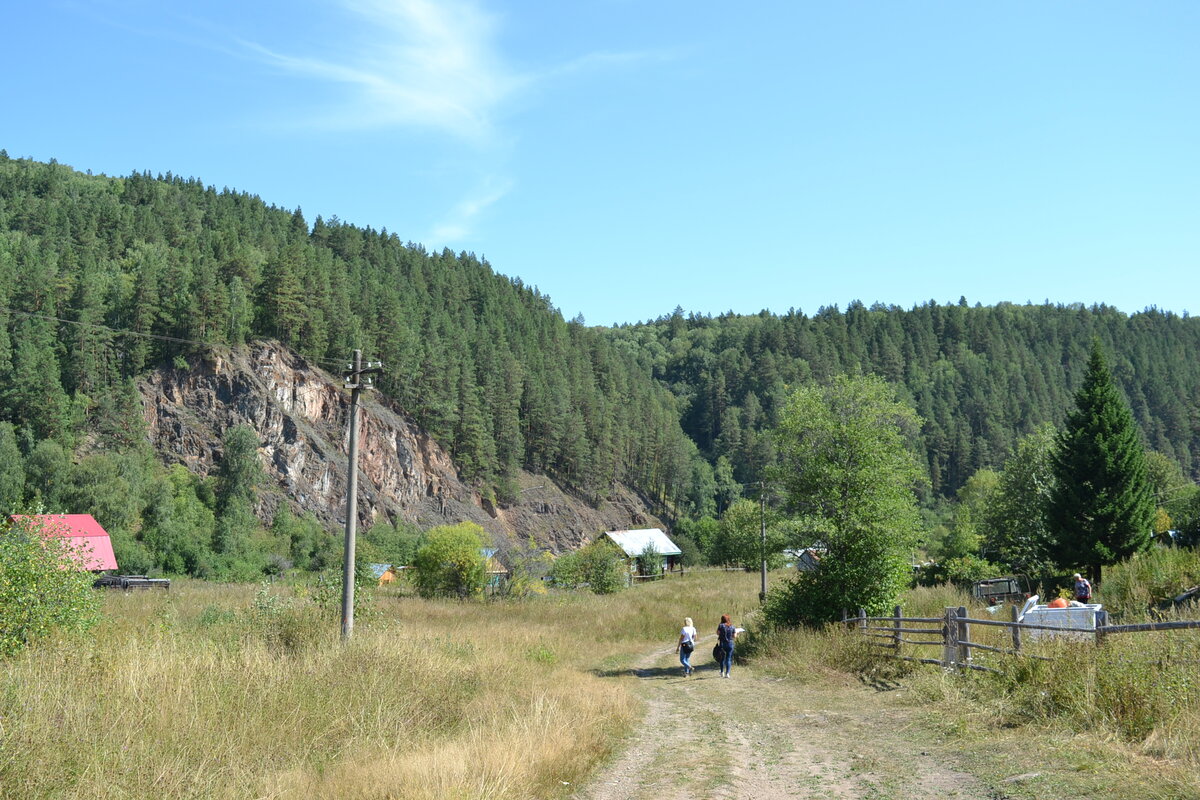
139 342 660 551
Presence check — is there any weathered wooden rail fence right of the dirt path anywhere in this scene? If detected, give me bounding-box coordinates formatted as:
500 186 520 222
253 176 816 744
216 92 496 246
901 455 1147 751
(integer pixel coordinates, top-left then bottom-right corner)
841 606 1200 673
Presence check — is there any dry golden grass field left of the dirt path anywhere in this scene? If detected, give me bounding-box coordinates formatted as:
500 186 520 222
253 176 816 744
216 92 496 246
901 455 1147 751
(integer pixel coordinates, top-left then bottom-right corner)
0 572 757 798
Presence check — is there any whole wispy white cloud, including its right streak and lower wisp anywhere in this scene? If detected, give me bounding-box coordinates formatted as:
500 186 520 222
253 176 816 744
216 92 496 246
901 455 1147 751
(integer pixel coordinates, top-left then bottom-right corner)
239 0 677 237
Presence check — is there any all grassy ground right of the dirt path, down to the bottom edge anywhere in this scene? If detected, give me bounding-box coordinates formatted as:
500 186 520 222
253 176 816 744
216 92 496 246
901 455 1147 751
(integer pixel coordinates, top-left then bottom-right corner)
755 578 1200 800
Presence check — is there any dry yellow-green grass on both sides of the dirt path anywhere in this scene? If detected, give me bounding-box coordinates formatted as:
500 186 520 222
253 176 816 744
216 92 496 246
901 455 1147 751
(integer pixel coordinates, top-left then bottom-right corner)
9 561 1200 800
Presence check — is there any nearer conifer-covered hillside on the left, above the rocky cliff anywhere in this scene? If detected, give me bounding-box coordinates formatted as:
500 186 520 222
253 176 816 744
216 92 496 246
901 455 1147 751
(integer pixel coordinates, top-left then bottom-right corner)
0 154 698 520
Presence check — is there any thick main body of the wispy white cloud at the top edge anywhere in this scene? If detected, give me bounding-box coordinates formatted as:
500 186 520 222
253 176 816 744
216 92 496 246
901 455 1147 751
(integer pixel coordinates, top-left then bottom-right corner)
244 0 526 143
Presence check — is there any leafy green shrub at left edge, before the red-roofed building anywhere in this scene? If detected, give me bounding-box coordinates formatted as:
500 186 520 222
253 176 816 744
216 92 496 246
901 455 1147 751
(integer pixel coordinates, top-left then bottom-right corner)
0 518 100 657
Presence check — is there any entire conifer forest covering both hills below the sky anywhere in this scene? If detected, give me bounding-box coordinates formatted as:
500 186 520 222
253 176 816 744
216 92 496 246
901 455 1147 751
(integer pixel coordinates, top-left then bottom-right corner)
0 151 1200 544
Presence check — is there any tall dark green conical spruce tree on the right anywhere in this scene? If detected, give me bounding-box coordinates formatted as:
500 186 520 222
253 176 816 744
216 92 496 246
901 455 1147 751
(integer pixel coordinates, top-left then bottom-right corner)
1046 341 1154 584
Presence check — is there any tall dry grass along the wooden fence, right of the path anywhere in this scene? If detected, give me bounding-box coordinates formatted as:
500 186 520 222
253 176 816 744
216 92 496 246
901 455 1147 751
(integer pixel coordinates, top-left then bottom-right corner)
757 575 1200 798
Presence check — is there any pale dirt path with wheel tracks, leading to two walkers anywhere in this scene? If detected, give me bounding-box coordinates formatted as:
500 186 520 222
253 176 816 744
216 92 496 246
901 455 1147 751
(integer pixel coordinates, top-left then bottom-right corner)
575 637 1003 800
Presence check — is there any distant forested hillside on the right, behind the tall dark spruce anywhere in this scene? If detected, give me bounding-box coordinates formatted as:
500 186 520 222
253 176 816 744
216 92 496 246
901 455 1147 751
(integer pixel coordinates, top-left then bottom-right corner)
612 300 1200 495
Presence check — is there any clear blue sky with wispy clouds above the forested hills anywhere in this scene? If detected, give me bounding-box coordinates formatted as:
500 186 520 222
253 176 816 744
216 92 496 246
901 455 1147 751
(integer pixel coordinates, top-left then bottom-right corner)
0 0 1200 324
